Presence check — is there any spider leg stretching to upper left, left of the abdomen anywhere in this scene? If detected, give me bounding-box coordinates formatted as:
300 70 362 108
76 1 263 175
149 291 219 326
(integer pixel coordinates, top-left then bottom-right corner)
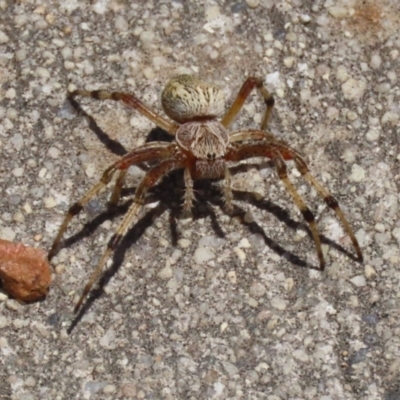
68 90 178 136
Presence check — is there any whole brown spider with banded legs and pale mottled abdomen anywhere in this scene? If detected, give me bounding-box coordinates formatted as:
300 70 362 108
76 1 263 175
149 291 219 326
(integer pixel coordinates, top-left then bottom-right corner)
49 75 362 312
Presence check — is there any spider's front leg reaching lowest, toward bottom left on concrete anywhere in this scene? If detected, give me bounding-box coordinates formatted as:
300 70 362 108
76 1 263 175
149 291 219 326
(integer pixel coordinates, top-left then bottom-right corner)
74 160 183 313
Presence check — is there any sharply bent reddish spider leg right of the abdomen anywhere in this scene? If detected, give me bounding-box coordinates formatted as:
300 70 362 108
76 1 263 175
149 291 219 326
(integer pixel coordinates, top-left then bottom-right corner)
221 77 275 130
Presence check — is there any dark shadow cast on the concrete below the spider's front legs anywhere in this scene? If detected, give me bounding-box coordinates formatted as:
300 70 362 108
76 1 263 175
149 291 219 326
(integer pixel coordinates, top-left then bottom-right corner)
62 171 357 334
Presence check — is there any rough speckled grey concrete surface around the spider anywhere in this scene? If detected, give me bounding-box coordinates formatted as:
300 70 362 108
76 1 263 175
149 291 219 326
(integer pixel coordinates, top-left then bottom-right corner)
0 0 400 400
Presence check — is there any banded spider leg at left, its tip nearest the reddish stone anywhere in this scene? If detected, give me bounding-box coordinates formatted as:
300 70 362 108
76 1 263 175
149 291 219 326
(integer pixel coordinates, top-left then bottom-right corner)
48 142 174 260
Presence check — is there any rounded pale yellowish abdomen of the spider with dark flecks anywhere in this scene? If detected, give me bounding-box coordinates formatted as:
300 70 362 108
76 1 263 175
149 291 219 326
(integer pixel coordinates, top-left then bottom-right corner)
161 75 225 123
